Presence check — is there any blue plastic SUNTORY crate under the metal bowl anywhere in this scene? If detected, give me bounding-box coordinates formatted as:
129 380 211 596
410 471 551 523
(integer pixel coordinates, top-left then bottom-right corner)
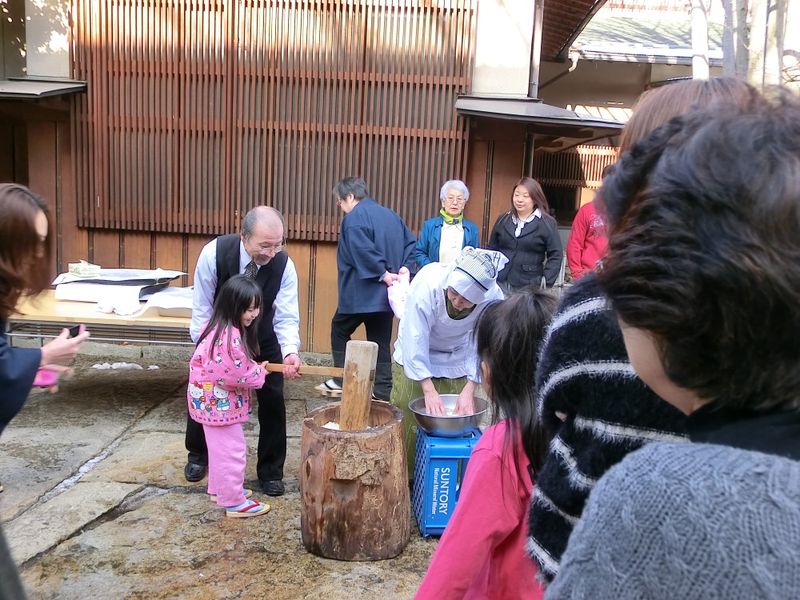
411 429 480 537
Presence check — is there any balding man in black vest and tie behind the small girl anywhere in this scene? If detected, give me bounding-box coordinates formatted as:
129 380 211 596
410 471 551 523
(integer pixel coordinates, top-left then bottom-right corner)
184 206 300 496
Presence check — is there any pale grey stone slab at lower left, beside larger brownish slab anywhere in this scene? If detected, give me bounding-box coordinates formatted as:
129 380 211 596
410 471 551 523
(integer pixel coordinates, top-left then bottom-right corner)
3 482 140 563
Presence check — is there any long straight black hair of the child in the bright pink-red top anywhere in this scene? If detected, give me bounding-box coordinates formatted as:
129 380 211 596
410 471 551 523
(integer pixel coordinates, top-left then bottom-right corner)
475 287 558 470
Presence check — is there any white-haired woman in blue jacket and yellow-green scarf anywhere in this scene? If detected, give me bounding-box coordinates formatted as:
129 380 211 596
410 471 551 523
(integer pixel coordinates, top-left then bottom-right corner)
417 179 479 269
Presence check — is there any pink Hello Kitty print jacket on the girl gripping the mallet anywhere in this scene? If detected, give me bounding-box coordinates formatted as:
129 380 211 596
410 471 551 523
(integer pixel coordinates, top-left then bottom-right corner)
186 327 267 425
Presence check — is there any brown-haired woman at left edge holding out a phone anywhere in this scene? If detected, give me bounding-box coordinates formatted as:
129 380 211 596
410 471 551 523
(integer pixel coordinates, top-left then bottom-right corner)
0 183 89 598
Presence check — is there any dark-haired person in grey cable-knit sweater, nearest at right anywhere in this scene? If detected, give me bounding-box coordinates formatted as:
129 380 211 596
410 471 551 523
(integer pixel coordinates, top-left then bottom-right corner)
548 94 800 600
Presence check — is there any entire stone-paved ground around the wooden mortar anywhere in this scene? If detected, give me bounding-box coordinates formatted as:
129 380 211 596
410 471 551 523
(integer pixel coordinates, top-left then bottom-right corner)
0 345 436 600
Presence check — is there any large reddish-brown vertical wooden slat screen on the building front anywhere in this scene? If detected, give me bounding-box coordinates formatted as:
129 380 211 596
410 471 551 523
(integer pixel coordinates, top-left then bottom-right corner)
72 0 477 241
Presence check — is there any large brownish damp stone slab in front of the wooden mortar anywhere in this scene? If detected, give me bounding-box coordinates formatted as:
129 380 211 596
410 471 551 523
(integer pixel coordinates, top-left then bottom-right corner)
23 492 435 600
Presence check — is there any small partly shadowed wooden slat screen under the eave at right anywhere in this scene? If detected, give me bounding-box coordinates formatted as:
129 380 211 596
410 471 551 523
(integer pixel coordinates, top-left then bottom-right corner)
533 145 617 188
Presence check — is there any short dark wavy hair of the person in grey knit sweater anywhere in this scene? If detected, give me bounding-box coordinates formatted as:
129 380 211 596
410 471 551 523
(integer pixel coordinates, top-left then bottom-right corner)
600 89 800 411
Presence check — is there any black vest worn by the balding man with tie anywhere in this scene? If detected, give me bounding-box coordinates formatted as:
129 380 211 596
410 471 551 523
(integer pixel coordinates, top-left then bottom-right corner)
214 233 289 362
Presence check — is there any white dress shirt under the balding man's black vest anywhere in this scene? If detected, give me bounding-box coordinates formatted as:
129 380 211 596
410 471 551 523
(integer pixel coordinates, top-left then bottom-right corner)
189 240 300 358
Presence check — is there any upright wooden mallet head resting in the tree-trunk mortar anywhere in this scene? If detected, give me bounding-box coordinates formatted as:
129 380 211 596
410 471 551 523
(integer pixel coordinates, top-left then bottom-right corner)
339 340 378 431
